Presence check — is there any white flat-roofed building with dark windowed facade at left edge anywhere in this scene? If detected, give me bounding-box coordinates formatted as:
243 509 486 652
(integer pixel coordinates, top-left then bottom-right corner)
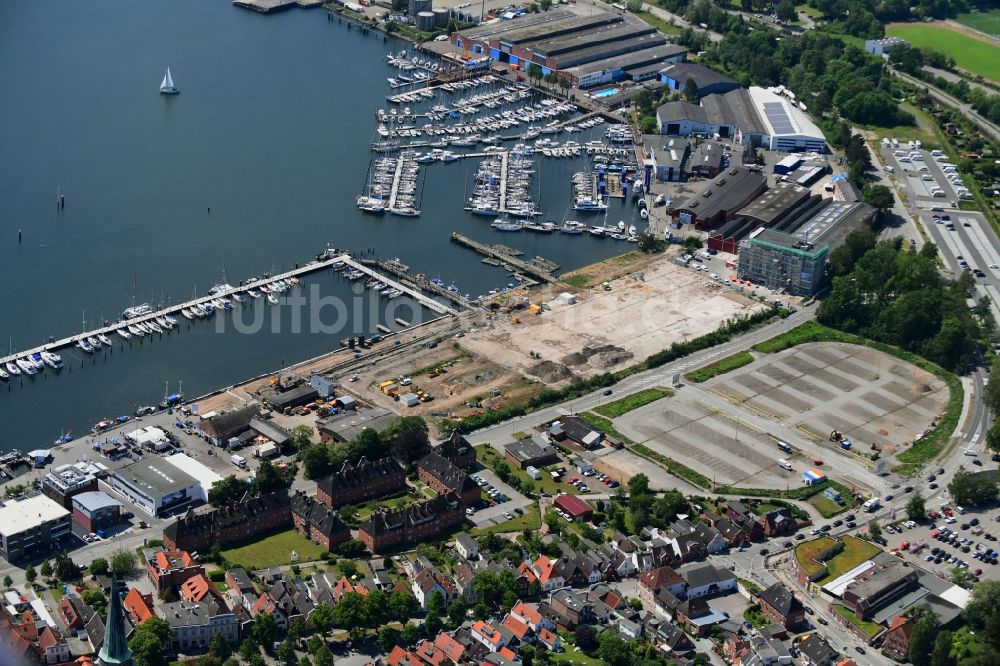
0 495 70 562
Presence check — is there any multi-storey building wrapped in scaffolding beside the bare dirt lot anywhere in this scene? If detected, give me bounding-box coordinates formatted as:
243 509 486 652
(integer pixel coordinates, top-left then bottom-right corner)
738 228 830 296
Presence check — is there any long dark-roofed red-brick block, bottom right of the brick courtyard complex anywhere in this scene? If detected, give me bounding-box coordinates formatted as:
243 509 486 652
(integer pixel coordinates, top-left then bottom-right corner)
358 493 465 553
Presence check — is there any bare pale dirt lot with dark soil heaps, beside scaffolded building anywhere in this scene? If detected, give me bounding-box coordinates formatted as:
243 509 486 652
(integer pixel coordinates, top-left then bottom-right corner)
462 257 762 383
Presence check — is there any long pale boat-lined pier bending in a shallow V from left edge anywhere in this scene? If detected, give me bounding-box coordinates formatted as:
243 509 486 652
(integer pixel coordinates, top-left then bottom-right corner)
0 252 458 364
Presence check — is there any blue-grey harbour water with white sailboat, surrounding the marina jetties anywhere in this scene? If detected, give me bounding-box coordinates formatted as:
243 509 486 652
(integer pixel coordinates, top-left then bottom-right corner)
0 0 631 450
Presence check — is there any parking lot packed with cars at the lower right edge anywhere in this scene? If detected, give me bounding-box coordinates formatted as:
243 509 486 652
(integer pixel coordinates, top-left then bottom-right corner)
883 502 1000 580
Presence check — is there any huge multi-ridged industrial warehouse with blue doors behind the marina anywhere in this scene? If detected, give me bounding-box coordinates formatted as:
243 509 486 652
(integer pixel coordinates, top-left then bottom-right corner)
453 7 687 88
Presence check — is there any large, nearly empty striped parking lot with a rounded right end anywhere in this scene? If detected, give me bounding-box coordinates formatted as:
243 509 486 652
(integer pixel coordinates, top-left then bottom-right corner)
615 343 948 492
